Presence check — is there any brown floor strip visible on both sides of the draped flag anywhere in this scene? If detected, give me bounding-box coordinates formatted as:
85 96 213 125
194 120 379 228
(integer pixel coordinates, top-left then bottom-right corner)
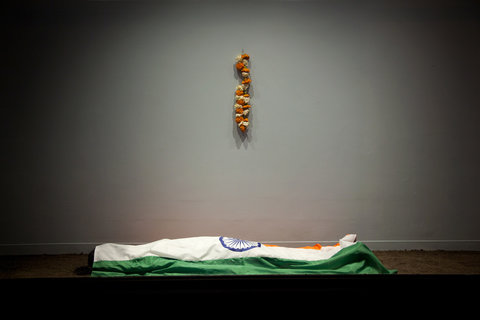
0 250 480 279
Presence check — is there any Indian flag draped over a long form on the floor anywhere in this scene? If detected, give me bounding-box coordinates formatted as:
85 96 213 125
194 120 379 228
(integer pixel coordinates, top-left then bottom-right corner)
92 234 396 277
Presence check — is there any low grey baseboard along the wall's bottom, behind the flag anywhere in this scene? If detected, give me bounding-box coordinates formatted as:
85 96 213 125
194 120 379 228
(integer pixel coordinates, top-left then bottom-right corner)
0 239 480 255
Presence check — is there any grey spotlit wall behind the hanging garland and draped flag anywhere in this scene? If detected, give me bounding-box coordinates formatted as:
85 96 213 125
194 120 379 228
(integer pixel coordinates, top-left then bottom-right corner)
0 1 480 253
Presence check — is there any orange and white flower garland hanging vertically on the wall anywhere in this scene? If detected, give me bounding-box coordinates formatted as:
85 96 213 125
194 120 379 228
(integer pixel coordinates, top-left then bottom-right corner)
234 54 252 132
